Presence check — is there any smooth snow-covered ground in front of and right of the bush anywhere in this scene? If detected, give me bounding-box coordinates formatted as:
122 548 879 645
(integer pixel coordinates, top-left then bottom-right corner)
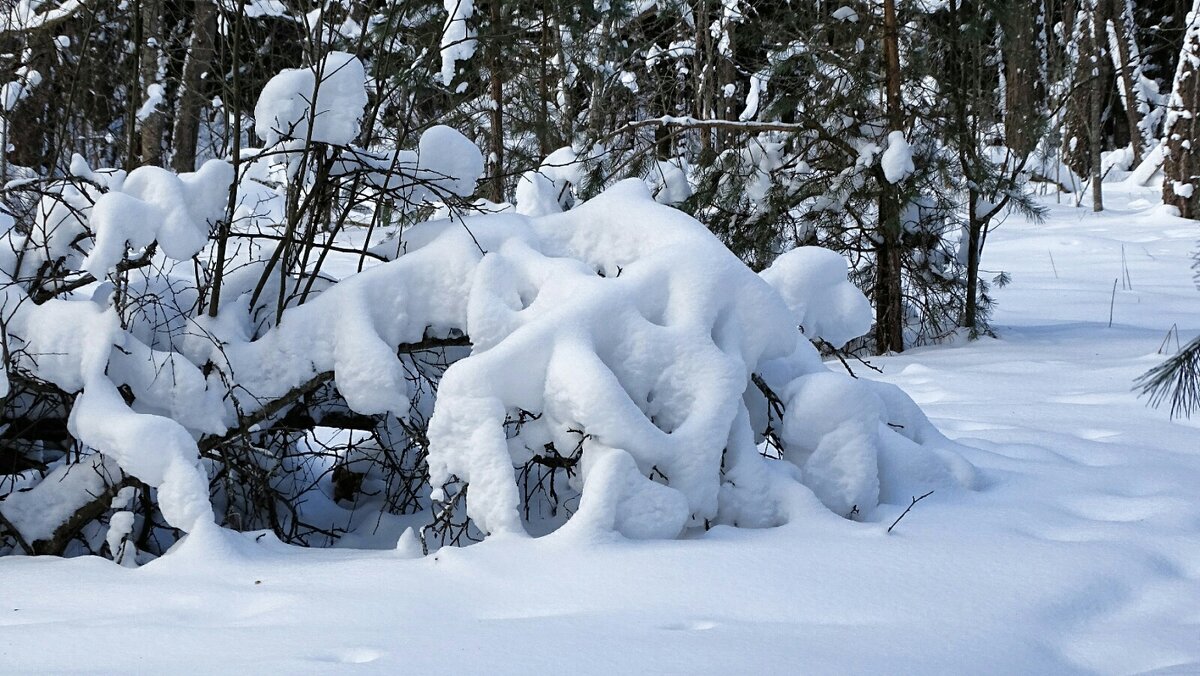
0 186 1200 674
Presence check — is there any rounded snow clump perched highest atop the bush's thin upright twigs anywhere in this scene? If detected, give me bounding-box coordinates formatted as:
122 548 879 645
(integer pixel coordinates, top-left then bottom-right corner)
254 52 367 145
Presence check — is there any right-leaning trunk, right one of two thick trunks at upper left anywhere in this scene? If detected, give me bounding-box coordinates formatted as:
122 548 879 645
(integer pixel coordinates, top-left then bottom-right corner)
170 0 217 173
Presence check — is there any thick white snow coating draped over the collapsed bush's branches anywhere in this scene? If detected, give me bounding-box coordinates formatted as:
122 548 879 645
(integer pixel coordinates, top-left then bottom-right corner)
0 53 972 549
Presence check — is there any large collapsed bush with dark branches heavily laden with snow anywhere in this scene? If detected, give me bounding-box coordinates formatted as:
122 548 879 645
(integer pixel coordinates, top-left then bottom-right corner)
0 54 971 561
